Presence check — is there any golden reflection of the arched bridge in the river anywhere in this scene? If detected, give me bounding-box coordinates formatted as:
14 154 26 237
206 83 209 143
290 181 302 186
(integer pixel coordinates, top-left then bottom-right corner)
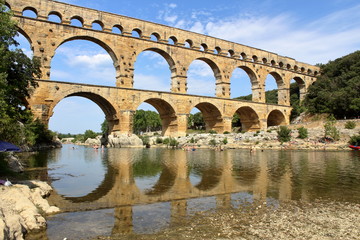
43 149 360 237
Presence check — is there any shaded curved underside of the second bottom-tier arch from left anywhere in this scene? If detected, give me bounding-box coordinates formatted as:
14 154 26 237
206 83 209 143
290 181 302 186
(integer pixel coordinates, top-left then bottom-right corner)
138 98 178 136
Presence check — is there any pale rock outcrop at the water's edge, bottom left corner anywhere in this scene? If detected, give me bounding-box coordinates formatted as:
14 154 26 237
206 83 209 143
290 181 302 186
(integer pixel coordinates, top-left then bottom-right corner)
0 181 60 240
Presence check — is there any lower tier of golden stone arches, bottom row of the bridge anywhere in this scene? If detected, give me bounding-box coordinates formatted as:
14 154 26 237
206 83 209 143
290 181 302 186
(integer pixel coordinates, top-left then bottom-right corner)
28 80 291 136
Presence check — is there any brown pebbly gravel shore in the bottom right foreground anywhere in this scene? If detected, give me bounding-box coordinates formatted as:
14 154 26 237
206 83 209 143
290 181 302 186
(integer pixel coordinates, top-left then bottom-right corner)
96 201 360 240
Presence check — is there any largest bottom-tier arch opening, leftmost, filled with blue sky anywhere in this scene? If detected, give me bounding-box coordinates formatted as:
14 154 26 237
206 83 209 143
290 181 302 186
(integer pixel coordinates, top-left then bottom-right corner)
49 92 119 135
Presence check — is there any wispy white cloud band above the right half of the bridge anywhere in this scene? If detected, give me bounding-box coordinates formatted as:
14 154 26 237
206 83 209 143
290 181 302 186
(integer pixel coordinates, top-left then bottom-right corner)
158 2 360 64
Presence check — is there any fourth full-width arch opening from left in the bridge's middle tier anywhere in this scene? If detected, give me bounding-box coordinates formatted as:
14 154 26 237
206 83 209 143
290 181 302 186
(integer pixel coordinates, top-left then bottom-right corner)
230 66 258 101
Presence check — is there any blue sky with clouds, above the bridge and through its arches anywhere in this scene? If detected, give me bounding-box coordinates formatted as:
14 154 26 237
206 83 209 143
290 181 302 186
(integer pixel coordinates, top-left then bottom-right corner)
15 0 360 133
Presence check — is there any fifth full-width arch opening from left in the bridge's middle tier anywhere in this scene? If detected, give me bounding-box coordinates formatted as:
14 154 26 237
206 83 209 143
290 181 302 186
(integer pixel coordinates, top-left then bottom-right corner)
265 72 284 104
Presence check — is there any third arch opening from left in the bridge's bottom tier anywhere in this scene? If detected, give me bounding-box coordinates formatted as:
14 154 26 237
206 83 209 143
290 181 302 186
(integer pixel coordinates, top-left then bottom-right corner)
188 102 223 133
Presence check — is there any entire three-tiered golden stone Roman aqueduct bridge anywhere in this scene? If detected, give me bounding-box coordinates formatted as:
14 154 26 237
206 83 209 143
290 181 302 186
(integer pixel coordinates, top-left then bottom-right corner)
6 0 319 136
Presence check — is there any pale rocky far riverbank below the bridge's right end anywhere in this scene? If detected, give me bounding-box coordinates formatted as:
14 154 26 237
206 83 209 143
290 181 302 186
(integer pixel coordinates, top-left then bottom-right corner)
149 119 360 151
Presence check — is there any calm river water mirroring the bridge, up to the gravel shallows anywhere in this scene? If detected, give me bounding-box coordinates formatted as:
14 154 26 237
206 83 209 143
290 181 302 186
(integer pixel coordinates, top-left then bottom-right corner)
25 145 360 240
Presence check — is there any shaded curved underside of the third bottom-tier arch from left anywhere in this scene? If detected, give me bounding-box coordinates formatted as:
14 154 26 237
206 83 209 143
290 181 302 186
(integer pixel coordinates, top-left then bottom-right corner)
191 102 223 133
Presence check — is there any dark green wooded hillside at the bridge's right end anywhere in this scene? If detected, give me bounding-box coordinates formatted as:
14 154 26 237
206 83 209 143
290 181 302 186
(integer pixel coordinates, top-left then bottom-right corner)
305 51 360 118
